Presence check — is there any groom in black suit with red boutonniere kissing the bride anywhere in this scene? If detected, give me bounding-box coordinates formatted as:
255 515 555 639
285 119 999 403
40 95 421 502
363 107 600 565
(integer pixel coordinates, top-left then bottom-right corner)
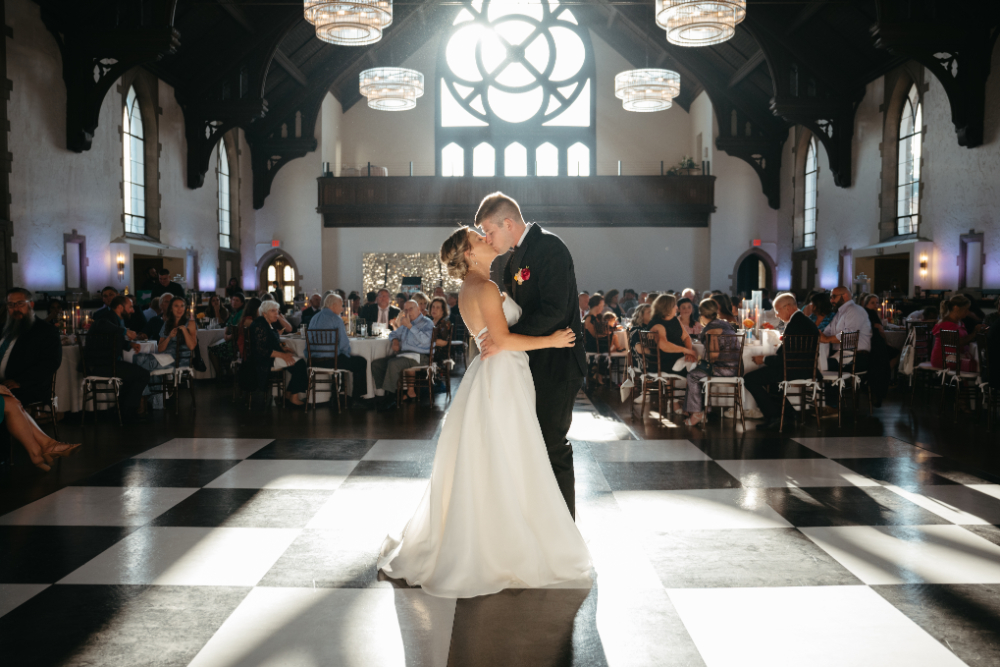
475 192 587 518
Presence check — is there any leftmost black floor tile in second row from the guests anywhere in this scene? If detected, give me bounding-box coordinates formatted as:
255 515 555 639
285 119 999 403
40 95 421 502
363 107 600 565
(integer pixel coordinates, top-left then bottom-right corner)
73 459 239 489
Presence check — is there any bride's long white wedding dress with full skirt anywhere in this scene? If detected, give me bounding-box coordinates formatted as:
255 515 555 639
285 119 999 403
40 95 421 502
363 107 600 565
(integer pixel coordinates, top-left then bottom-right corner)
378 298 590 598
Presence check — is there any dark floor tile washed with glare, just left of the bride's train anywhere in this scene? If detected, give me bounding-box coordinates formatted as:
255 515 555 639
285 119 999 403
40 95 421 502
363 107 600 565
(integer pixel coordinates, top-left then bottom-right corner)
257 530 379 588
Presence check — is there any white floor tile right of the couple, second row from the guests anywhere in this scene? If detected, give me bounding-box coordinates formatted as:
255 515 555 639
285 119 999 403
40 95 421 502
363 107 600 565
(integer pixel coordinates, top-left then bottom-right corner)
716 459 881 488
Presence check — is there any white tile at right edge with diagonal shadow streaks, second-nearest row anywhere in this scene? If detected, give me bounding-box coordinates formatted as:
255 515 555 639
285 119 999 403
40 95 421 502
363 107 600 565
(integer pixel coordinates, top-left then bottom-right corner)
799 526 1000 585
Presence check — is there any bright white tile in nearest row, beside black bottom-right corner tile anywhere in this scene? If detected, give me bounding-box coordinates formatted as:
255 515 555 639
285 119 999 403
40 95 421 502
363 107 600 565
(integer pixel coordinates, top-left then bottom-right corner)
668 586 965 667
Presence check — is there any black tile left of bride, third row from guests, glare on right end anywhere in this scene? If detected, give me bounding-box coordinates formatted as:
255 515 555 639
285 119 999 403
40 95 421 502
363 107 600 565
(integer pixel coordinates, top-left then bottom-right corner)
153 489 333 528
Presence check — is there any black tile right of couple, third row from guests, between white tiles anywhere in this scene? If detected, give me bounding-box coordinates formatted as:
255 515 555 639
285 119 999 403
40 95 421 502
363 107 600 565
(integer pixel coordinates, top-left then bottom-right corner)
764 486 949 527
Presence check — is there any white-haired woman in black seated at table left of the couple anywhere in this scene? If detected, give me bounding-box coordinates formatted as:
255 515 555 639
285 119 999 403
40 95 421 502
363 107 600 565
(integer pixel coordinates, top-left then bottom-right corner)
240 299 307 409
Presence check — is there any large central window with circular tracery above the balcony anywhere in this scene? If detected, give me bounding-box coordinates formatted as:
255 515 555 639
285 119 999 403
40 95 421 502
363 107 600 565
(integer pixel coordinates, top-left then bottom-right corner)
435 0 597 176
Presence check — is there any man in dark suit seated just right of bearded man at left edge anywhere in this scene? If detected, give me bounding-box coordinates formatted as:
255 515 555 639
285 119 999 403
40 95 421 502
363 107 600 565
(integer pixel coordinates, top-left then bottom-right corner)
83 297 155 423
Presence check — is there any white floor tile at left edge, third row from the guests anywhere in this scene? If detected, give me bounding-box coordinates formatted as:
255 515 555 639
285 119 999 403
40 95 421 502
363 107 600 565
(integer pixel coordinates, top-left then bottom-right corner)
0 486 198 526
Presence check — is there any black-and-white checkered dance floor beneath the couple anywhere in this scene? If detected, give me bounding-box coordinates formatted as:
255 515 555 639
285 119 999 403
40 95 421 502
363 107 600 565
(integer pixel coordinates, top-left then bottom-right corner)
0 401 1000 667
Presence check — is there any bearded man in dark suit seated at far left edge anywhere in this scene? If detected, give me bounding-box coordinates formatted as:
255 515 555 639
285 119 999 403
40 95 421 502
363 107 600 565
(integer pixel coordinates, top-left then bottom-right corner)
0 287 62 404
